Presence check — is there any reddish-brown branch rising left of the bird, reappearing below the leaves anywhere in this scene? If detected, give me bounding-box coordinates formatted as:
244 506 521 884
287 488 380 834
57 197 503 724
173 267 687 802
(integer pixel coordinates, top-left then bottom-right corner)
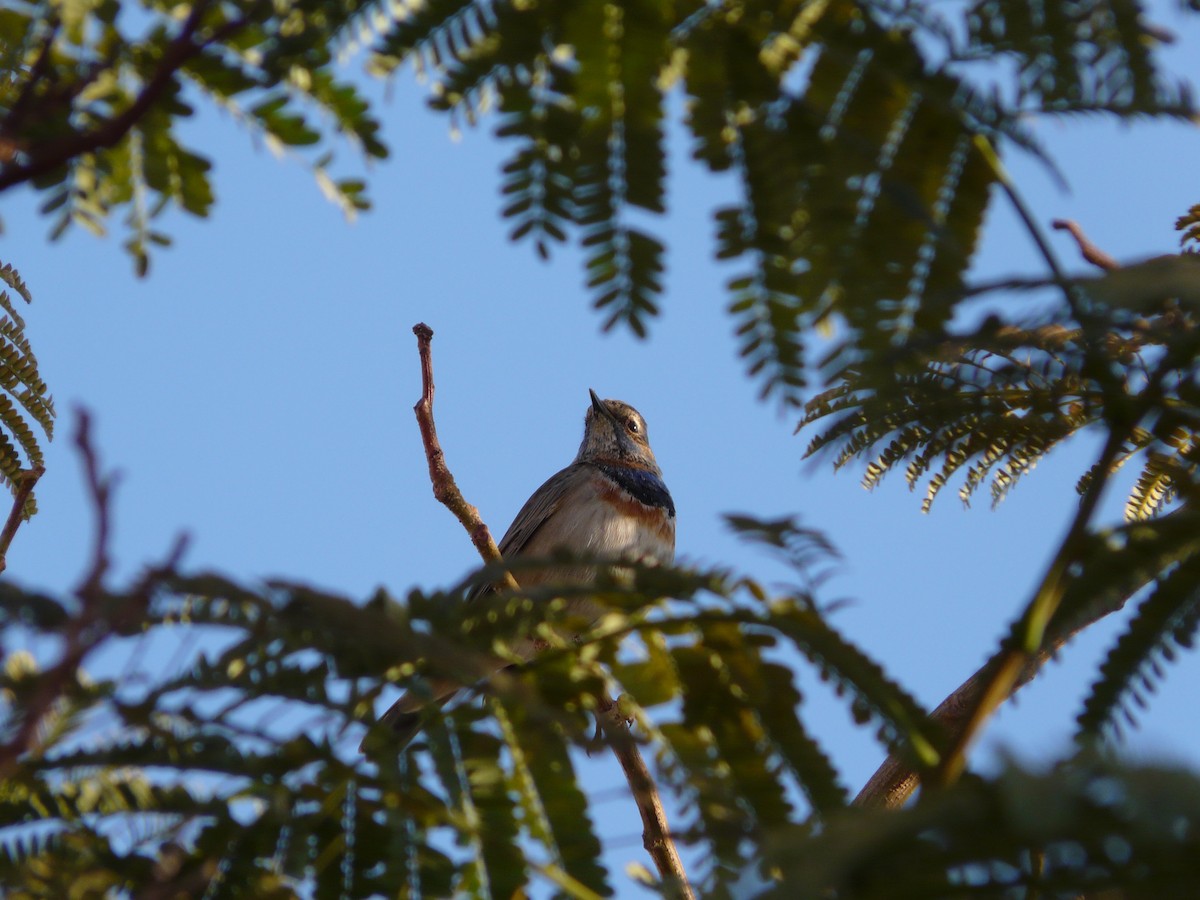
413 323 695 900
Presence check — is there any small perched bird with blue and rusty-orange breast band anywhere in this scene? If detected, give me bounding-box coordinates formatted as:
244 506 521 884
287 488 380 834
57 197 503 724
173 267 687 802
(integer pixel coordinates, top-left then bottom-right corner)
364 390 676 748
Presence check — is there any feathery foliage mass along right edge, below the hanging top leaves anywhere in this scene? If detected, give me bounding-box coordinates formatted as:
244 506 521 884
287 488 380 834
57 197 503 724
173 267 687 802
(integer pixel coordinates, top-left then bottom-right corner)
798 247 1200 744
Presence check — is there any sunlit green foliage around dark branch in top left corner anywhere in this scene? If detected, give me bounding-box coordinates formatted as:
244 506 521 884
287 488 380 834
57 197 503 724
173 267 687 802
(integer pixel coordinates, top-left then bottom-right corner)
0 0 386 275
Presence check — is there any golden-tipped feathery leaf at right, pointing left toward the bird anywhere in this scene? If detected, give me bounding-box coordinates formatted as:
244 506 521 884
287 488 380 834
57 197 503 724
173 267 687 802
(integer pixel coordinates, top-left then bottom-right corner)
798 303 1200 518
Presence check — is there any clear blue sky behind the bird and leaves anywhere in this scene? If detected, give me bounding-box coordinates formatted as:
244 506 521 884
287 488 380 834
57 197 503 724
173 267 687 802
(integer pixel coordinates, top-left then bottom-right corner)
0 5 1200 897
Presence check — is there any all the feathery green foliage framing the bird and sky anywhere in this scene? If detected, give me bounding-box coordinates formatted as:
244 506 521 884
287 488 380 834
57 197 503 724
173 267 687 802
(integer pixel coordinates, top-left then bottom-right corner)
0 0 1200 898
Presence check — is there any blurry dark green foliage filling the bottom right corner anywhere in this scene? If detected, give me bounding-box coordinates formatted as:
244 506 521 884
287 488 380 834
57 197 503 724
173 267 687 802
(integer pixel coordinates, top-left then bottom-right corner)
760 762 1200 900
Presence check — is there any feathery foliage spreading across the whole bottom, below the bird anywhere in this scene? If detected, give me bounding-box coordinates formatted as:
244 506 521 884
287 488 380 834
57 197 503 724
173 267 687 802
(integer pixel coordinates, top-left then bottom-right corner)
7 508 1200 898
